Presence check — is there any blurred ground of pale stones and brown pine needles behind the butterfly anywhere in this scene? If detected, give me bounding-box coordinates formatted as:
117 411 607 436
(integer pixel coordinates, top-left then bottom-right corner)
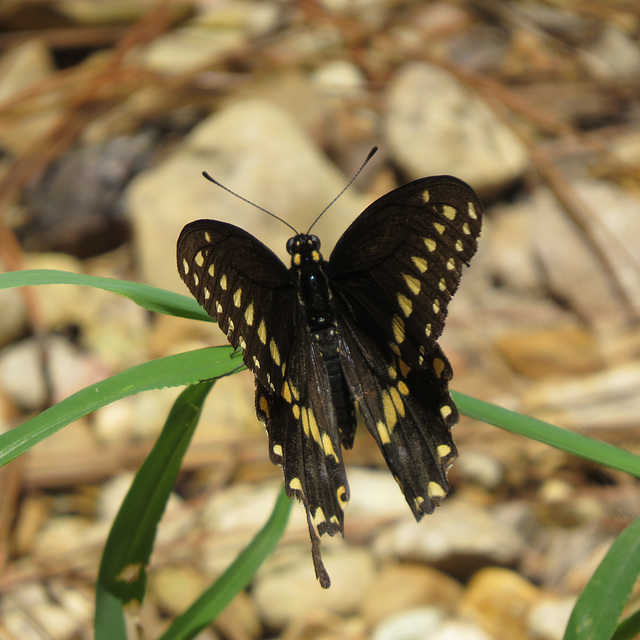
0 0 640 640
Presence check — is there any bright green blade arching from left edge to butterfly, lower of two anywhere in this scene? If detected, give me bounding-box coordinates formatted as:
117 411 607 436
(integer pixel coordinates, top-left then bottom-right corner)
0 347 242 467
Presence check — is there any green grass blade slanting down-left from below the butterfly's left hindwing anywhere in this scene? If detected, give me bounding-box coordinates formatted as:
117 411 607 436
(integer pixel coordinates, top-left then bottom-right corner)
161 487 292 640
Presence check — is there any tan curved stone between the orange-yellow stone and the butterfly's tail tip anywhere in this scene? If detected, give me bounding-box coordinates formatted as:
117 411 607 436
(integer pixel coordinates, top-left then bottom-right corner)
362 564 462 628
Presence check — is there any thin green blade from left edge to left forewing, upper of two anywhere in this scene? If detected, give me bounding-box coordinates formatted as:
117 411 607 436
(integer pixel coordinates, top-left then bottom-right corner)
0 269 214 322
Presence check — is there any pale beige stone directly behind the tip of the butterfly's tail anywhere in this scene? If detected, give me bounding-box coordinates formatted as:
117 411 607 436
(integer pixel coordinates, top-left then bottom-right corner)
253 537 375 630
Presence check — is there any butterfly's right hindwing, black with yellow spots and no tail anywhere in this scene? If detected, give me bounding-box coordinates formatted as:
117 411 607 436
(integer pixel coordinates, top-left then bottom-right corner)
340 310 458 520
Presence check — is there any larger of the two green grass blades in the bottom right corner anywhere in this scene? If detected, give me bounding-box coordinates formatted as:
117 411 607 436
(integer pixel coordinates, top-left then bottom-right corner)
564 518 640 640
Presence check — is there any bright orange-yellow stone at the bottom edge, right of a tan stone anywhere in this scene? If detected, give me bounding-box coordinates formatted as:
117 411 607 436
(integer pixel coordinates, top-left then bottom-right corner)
460 567 542 640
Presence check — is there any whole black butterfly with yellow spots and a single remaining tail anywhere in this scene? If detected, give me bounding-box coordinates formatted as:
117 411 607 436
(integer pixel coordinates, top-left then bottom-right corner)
178 155 482 588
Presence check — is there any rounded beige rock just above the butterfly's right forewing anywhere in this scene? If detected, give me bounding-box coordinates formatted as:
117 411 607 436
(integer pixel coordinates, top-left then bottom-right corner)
385 63 528 196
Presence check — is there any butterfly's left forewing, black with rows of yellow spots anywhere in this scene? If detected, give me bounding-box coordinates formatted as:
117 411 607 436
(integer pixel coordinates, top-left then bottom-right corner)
177 220 296 393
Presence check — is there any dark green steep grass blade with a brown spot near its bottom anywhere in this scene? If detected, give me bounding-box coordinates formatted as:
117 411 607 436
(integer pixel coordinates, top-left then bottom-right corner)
95 381 213 640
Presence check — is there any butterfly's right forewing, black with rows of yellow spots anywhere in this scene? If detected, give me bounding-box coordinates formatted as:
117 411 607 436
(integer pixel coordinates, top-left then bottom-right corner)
329 176 482 365
